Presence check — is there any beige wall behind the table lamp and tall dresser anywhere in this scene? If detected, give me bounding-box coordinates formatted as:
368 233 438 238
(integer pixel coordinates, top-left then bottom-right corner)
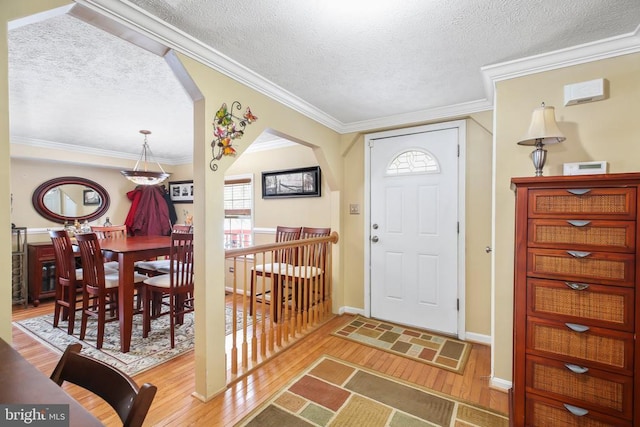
494 54 640 380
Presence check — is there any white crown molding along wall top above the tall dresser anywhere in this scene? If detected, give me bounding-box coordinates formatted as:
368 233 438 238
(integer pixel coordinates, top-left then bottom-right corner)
480 26 640 104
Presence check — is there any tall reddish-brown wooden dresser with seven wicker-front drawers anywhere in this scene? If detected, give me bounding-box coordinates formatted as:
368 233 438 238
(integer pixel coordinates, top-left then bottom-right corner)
511 173 640 427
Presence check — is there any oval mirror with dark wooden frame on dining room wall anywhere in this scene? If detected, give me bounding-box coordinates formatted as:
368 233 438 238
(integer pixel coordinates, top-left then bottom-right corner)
31 176 111 224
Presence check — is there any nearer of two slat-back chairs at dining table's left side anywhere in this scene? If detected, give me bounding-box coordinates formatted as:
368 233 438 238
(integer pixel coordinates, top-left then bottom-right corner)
76 233 147 349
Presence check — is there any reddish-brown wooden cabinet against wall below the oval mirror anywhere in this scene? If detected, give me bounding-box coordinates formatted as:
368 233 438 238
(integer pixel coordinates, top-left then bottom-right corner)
27 242 56 307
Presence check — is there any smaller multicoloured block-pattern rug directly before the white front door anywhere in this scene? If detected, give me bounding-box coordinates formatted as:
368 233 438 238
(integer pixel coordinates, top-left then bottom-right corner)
333 316 472 374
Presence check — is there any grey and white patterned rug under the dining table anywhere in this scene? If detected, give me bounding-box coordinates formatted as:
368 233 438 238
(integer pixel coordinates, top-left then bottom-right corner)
13 307 252 376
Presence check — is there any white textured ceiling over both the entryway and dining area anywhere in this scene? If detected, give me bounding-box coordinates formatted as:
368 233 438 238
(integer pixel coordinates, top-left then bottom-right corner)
9 0 640 163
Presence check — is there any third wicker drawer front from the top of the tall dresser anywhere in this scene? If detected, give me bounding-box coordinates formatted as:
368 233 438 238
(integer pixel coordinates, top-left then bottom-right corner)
527 249 635 286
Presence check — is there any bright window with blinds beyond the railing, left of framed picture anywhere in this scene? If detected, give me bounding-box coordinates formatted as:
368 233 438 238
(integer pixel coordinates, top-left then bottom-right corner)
224 178 253 249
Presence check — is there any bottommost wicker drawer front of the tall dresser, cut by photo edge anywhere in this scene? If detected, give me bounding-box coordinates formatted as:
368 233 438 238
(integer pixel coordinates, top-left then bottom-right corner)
526 394 633 427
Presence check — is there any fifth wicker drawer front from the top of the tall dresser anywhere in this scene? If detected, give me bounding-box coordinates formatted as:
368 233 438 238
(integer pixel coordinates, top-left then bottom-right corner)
527 317 633 375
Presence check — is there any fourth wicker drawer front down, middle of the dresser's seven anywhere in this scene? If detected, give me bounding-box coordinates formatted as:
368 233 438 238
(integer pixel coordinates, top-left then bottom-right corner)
527 279 635 332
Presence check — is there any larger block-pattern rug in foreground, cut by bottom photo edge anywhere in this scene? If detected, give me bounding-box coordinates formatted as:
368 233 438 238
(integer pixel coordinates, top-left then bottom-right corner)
236 356 509 427
